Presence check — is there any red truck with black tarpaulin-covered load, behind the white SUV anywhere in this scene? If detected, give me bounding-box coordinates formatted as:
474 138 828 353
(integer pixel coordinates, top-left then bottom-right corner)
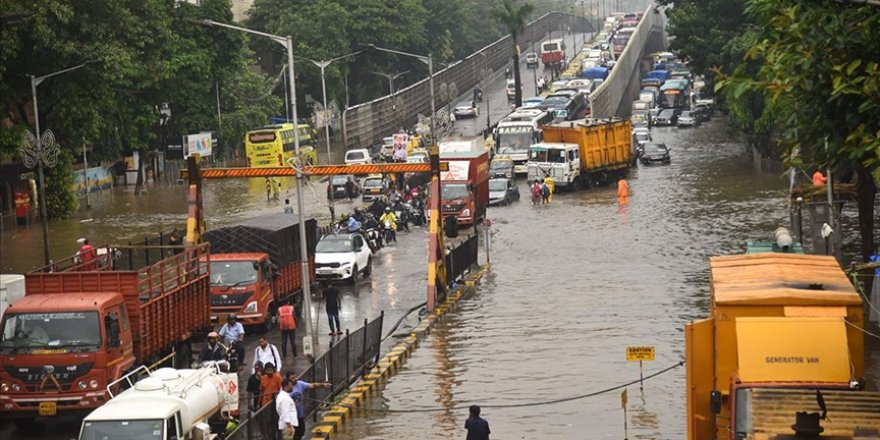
205 213 317 331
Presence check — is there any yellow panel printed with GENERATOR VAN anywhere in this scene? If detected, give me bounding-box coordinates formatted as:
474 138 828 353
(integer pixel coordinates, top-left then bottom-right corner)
736 317 850 383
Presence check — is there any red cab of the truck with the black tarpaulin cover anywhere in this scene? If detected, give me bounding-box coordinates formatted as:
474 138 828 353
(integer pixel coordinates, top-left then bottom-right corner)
211 252 275 325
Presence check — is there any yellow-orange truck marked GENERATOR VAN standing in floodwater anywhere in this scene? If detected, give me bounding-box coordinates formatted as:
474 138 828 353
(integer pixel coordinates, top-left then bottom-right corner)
685 253 880 440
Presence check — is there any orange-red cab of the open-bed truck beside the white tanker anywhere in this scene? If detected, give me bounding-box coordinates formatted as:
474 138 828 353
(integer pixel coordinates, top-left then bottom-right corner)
0 292 135 419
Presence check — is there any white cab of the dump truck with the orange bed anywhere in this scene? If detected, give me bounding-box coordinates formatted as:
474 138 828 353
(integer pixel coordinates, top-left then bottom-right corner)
528 143 581 189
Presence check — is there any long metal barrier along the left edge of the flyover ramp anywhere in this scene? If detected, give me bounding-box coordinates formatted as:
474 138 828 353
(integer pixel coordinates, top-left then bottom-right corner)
342 12 593 149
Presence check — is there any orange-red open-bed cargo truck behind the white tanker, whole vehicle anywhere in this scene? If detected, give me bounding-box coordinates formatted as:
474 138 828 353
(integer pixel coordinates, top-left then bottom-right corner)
0 245 211 425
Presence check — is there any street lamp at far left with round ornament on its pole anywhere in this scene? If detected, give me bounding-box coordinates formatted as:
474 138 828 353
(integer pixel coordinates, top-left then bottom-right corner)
21 61 93 266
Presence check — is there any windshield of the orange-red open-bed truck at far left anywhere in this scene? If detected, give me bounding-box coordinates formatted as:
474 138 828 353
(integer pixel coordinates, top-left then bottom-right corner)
0 312 101 353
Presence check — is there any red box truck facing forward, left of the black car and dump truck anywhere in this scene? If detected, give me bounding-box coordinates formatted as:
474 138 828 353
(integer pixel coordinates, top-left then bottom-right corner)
440 151 489 225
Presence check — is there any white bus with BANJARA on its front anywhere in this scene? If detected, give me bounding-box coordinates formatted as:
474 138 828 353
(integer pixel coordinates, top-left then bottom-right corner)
495 108 555 174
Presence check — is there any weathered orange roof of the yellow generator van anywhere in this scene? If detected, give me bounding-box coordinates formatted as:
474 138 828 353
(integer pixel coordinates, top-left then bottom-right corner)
709 253 862 306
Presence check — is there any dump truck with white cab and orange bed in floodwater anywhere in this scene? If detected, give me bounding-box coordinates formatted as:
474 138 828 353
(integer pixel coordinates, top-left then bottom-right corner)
527 118 632 190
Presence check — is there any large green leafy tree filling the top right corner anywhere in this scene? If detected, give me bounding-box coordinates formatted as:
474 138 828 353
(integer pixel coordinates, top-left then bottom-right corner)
719 0 880 259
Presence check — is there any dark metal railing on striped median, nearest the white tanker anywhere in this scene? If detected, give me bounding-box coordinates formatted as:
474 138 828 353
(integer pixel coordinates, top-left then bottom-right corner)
226 312 385 440
